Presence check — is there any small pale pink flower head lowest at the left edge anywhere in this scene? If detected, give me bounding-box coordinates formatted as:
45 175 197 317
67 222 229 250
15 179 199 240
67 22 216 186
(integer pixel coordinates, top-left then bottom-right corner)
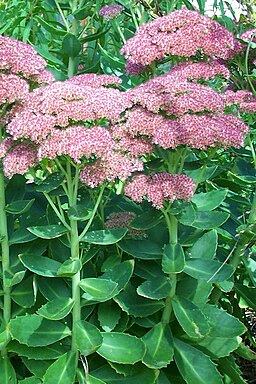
3 141 37 179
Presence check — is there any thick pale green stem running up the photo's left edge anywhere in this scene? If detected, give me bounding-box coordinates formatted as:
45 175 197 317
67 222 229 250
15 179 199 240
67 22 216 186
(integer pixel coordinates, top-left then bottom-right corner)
0 171 11 356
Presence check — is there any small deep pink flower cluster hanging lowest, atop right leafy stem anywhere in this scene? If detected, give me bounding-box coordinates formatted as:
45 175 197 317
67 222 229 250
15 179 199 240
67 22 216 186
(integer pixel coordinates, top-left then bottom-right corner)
125 172 195 209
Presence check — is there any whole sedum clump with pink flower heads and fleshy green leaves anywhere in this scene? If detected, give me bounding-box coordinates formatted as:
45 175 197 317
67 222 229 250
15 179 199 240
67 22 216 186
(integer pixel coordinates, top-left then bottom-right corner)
0 5 255 384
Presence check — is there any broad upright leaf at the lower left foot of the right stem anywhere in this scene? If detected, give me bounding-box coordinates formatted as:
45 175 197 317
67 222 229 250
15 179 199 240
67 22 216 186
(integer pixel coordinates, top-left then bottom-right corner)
142 323 174 369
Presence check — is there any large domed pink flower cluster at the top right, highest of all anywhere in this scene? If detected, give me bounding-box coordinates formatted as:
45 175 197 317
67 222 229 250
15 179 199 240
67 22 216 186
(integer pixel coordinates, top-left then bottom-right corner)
121 9 235 71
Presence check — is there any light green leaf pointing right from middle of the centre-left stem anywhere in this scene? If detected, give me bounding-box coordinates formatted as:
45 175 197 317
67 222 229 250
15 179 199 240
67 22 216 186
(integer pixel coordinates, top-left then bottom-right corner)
80 277 118 302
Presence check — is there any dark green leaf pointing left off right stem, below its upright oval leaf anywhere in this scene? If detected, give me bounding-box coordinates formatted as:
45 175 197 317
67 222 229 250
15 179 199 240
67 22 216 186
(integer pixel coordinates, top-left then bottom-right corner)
137 276 171 300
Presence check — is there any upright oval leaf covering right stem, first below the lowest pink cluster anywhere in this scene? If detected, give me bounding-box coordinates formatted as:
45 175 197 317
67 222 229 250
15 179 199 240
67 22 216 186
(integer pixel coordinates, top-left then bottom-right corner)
162 244 185 273
